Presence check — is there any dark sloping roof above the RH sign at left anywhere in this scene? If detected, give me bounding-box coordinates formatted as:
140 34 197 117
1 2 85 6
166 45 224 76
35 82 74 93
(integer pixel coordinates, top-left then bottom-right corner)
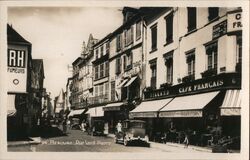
7 24 31 45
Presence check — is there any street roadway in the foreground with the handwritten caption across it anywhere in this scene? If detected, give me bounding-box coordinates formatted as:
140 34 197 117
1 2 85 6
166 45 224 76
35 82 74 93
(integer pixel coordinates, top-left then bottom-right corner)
8 126 207 153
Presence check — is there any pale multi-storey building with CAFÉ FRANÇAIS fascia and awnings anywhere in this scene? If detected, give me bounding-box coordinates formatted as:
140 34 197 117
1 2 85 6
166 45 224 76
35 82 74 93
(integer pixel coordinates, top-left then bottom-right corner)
130 7 242 149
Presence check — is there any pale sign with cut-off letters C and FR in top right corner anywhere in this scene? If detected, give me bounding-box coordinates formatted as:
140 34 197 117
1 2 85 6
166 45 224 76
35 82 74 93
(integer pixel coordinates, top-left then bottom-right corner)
227 11 242 33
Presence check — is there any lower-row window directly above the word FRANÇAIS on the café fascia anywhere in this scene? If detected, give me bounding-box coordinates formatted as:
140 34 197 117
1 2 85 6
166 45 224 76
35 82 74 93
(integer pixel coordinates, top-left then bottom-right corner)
206 42 218 71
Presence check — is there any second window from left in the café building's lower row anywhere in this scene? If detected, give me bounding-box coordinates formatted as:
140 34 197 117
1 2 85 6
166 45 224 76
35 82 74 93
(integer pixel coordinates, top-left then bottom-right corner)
165 51 173 84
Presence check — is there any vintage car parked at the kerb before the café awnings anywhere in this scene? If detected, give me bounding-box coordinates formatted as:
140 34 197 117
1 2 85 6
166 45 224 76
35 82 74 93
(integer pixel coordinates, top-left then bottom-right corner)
114 120 149 146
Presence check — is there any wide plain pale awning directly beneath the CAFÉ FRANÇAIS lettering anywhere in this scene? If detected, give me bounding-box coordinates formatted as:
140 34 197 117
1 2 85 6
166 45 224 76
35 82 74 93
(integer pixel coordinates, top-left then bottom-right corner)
159 91 219 117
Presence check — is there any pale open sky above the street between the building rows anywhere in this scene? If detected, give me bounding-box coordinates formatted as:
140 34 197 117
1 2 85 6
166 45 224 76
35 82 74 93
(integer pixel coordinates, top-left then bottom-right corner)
8 7 123 98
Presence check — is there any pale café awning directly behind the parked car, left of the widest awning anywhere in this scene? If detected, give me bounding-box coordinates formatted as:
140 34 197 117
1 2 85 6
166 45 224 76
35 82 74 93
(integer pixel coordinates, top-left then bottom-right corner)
129 98 173 118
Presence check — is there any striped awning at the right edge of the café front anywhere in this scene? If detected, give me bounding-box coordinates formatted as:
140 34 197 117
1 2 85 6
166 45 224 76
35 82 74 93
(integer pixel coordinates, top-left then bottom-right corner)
220 90 241 116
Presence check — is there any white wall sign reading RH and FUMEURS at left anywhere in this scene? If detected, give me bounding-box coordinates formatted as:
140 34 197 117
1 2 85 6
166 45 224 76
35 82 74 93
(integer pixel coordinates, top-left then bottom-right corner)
7 49 28 93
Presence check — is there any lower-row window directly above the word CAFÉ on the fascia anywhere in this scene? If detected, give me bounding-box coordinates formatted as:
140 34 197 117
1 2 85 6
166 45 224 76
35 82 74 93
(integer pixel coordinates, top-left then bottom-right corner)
186 50 195 77
